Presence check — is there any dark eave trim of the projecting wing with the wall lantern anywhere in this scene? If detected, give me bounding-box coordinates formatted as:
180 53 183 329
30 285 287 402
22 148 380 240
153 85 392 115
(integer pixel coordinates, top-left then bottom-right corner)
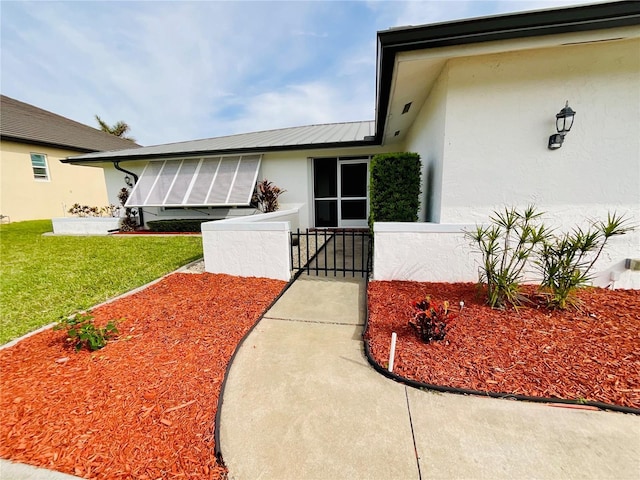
375 1 640 144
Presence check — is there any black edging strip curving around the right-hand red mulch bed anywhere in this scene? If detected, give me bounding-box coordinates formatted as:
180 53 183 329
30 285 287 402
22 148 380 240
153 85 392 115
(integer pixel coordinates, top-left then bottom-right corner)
362 279 640 415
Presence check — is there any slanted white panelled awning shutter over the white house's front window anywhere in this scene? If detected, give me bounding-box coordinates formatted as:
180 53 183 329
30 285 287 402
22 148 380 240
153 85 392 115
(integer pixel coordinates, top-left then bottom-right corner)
126 155 262 207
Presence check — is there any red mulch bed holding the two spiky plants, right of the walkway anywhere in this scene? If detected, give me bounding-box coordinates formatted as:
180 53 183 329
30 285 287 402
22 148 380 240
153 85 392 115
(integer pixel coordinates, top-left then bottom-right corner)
367 282 640 409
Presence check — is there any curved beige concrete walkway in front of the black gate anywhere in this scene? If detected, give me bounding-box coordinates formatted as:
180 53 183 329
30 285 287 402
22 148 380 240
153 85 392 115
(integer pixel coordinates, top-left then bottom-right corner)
220 276 640 480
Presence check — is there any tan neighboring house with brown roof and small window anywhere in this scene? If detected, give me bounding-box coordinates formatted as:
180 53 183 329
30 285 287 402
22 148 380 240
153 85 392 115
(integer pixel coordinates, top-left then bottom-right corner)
0 95 137 222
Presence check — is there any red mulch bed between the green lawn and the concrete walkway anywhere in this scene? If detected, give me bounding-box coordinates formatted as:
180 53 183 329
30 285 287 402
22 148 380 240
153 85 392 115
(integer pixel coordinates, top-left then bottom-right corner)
0 273 285 480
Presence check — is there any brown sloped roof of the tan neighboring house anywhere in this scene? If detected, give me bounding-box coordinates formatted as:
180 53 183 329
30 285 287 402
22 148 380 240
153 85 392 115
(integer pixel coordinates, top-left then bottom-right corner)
0 95 139 152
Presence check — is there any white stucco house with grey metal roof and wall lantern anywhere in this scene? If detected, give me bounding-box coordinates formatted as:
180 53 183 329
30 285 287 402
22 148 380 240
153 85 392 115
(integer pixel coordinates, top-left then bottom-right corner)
63 2 640 288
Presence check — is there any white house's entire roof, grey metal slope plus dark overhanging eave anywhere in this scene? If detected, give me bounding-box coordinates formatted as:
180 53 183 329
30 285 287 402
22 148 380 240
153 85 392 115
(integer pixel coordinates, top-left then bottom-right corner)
63 2 640 163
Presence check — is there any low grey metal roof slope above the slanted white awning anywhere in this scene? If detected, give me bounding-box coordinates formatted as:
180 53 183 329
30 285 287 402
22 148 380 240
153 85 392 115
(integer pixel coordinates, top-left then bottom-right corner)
63 120 375 163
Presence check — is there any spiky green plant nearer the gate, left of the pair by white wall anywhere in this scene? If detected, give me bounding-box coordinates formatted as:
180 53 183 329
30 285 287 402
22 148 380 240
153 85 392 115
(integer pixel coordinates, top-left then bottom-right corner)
466 206 549 308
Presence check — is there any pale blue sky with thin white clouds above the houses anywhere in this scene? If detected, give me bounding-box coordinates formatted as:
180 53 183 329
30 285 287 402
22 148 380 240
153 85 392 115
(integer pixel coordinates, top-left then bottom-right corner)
0 0 596 145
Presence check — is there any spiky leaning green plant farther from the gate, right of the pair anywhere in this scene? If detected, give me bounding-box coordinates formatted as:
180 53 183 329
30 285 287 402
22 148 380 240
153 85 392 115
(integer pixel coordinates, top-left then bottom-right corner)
537 212 633 309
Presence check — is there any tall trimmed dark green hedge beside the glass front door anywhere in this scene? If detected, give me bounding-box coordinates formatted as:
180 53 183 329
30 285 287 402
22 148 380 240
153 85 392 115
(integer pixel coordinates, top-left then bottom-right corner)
369 152 422 226
